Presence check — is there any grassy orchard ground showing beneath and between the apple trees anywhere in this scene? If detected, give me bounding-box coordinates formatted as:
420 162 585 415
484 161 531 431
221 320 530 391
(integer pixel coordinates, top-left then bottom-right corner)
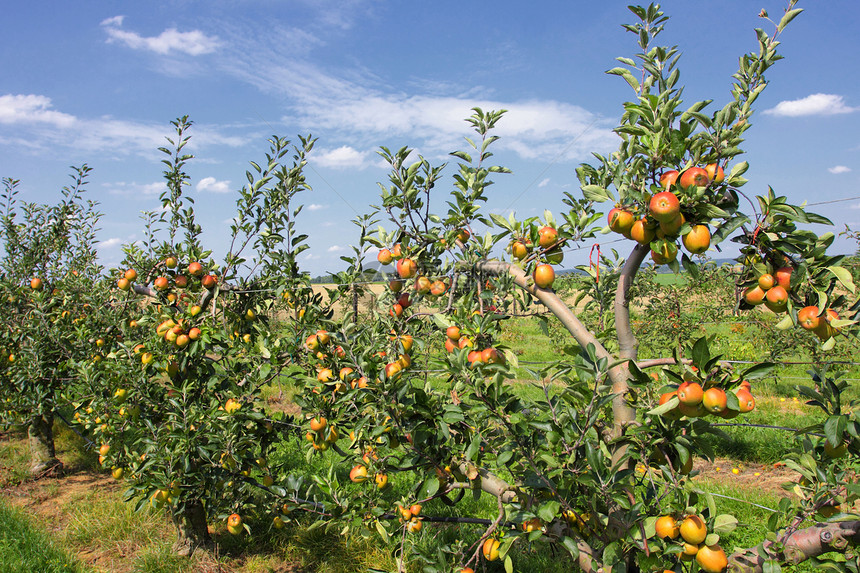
0 308 860 573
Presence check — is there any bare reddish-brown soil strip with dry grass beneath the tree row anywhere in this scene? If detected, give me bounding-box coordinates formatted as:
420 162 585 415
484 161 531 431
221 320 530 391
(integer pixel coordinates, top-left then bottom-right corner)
0 424 808 573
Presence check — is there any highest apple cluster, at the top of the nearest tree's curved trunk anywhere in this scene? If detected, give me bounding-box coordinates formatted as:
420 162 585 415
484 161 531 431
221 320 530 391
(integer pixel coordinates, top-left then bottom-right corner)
608 163 726 265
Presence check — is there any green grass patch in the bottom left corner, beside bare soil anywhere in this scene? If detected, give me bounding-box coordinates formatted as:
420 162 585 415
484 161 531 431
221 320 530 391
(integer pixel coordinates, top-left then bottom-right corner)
0 498 90 573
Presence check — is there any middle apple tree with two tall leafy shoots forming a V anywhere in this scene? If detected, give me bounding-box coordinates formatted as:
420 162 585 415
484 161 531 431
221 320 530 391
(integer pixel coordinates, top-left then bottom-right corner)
76 117 314 554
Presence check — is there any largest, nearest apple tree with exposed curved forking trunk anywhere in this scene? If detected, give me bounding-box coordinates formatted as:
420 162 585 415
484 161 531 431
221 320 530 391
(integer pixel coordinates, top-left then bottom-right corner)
284 2 860 571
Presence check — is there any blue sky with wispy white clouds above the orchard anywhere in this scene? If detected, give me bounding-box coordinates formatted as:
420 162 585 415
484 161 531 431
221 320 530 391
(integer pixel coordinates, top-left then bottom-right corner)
0 0 860 275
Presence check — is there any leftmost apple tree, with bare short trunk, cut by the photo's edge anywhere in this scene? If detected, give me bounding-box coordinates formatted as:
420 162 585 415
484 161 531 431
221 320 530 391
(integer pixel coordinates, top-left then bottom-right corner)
0 165 106 477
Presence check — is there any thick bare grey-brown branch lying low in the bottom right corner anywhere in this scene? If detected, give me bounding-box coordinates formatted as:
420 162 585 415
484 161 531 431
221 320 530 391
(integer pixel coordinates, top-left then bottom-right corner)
728 520 860 573
